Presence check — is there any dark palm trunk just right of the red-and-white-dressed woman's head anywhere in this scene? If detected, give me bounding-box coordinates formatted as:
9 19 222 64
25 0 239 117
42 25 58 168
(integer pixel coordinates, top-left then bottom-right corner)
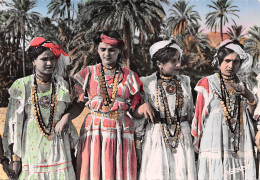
123 21 131 68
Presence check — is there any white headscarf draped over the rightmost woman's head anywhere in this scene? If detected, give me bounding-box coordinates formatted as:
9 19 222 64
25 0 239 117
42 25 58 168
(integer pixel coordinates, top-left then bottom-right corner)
212 39 253 79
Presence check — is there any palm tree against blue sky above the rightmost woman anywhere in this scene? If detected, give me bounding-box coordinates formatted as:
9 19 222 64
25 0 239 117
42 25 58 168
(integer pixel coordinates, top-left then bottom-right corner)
206 0 239 41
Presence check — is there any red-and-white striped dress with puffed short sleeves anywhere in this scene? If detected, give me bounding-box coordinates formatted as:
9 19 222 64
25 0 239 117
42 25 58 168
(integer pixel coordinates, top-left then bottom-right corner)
74 64 142 179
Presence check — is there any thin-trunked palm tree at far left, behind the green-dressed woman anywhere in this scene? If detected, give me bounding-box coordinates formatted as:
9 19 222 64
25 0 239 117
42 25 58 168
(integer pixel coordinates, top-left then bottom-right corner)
6 0 40 76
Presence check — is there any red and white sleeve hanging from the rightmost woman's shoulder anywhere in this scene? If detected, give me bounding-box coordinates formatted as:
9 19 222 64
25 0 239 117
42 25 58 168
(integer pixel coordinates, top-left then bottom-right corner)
191 78 209 152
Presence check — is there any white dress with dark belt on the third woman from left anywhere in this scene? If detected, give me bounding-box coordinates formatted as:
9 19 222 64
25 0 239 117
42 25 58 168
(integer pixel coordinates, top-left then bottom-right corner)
135 73 196 180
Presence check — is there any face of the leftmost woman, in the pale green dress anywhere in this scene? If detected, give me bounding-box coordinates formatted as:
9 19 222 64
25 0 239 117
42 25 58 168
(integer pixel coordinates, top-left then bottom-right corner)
33 49 57 75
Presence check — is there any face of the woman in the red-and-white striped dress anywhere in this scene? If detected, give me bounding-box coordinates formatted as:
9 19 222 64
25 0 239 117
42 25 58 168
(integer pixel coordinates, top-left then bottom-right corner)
98 42 120 68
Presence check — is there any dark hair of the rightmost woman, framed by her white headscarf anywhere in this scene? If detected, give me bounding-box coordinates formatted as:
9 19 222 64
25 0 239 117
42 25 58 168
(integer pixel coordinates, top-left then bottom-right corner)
217 40 244 66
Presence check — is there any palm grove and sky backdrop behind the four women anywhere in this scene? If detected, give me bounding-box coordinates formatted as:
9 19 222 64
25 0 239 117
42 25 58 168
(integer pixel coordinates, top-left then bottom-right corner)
0 0 260 179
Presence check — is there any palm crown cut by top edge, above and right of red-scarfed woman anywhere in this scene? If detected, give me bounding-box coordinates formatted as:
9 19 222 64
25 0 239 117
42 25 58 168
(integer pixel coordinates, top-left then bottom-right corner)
47 0 71 26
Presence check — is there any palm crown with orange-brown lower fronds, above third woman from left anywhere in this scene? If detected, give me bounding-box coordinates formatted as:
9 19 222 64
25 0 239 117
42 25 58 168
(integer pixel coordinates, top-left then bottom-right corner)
167 0 201 36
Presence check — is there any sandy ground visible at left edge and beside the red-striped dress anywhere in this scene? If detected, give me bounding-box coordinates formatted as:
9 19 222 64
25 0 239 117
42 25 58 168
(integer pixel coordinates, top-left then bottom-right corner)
0 108 88 179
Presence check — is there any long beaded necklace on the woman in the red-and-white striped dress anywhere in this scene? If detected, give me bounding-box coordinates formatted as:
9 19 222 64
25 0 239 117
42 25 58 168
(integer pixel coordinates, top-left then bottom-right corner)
98 64 120 112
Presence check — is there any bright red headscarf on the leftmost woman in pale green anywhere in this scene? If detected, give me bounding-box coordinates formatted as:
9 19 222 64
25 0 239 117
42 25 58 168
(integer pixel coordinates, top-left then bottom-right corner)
30 37 68 59
